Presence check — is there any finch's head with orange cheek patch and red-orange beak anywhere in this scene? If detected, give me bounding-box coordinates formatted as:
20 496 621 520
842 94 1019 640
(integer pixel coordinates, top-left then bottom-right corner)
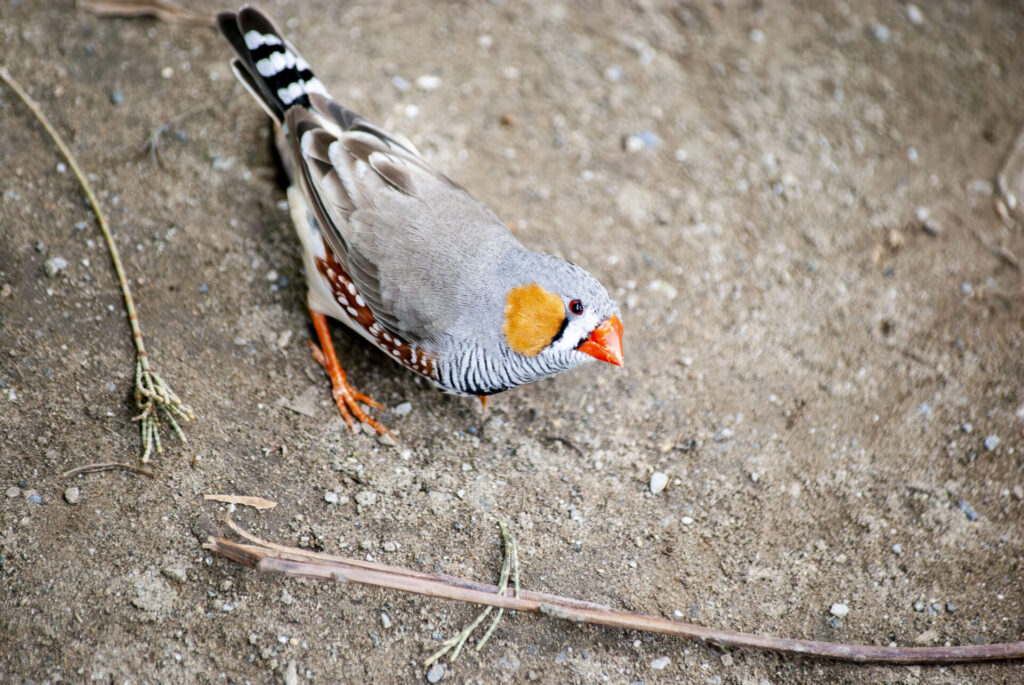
502 255 623 375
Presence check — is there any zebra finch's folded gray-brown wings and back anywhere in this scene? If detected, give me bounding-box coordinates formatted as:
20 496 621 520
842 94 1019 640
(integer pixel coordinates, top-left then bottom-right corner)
286 96 519 343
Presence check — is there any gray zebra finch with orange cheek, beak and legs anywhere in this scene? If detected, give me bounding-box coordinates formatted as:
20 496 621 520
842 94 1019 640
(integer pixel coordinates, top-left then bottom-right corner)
217 5 623 436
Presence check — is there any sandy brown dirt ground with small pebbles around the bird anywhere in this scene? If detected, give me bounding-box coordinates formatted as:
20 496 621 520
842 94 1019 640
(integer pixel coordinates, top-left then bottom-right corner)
0 0 1024 684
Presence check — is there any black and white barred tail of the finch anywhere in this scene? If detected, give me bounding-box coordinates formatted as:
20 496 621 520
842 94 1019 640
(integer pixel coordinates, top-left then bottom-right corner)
217 5 328 122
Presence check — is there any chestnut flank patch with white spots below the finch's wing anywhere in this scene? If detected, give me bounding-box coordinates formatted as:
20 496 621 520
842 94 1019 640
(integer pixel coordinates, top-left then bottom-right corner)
315 246 440 384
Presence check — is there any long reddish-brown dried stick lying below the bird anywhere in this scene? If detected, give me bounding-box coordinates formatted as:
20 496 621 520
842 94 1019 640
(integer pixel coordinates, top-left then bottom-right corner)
203 518 1024 663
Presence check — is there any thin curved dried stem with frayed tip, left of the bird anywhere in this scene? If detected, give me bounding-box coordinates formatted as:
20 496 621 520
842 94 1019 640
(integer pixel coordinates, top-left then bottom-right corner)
0 66 193 462
